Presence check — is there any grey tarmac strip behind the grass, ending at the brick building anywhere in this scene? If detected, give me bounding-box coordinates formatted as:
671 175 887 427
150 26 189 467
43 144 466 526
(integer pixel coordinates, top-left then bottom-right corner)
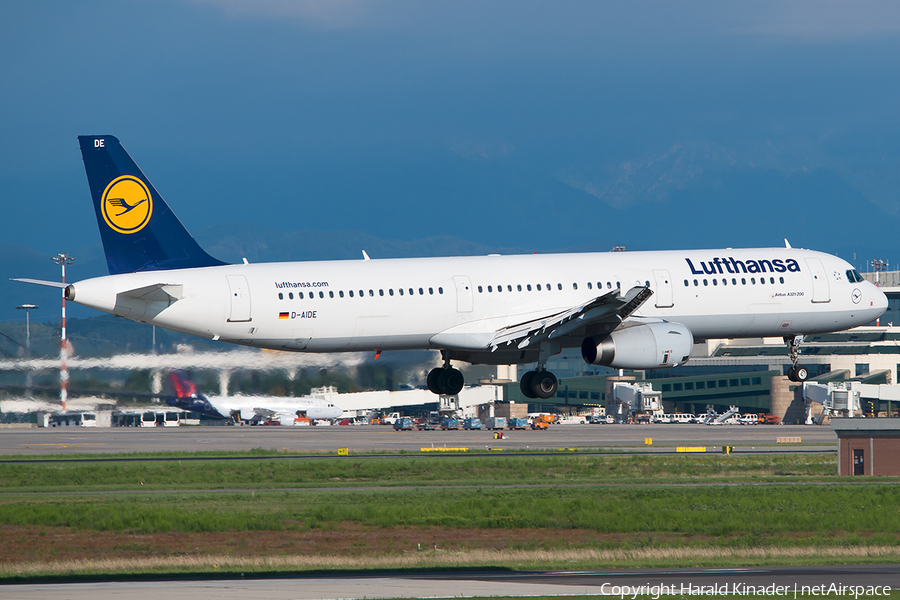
0 424 837 456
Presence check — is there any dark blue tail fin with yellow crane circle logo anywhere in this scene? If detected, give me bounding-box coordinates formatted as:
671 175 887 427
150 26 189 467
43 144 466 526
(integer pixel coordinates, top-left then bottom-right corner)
78 135 225 275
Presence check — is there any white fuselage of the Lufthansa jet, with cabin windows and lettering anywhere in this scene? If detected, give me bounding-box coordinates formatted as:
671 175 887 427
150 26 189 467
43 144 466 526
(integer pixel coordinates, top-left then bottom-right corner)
72 248 887 362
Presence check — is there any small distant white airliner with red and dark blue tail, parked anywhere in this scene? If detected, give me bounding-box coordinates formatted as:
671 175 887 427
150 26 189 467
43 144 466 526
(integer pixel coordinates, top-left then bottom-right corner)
166 372 343 423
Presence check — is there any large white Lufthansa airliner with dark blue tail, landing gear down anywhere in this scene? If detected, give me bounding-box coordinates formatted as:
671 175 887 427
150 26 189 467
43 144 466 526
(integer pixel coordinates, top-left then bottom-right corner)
14 135 887 398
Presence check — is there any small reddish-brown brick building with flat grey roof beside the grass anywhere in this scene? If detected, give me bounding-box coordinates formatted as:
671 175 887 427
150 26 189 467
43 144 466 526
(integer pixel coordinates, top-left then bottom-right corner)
831 417 900 477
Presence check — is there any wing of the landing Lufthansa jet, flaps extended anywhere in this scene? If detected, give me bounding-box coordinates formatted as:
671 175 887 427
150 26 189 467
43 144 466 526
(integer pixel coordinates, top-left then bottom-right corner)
490 286 653 352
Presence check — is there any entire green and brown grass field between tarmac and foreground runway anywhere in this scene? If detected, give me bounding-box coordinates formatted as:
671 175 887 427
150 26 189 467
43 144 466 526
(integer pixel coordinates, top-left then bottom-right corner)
0 454 900 578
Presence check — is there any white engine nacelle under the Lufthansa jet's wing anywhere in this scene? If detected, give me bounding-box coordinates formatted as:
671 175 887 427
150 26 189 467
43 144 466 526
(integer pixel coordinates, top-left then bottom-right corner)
581 323 694 369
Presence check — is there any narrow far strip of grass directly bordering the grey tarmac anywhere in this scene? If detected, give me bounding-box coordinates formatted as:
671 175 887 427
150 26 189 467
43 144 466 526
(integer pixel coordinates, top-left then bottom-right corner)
0 454 839 493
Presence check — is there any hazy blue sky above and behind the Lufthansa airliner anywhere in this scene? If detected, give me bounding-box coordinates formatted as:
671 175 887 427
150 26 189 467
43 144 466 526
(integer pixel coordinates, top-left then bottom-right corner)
0 0 900 261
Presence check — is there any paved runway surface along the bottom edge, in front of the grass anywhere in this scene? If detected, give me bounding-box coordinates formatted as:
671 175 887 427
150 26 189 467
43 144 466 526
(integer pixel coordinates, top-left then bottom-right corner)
0 565 900 600
